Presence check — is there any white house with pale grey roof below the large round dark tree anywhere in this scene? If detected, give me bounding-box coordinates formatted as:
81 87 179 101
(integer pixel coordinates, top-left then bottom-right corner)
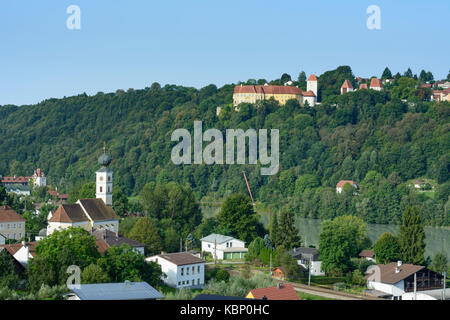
200 233 248 260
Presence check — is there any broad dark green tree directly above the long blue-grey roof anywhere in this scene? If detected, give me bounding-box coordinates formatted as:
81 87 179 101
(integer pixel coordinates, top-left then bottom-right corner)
97 244 162 286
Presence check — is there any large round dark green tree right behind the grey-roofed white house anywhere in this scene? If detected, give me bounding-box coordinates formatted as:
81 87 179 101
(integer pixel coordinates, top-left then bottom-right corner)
217 194 259 243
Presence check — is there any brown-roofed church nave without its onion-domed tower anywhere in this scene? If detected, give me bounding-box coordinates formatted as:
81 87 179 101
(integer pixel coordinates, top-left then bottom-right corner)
47 199 119 235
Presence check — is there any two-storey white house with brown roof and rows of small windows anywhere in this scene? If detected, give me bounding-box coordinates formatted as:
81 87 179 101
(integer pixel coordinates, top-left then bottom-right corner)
145 252 205 289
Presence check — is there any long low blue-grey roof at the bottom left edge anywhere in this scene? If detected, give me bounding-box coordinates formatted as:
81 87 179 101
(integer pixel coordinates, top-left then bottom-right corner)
67 281 164 300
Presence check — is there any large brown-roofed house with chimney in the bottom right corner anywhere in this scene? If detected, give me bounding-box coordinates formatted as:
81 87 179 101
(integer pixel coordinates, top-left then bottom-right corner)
366 261 444 300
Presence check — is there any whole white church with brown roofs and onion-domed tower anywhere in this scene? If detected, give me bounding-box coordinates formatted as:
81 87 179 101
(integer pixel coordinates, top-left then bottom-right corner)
47 147 119 235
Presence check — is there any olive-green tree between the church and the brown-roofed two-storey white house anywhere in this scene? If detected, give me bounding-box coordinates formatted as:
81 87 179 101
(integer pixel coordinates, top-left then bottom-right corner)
128 217 163 255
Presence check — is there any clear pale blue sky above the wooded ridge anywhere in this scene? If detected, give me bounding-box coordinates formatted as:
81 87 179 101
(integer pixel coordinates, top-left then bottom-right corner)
0 0 450 105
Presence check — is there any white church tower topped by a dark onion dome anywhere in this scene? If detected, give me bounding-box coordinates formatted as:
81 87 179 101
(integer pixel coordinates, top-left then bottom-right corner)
95 143 113 207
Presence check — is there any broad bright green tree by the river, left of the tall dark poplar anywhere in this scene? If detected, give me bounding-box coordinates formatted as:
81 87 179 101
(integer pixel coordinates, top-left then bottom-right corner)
319 216 367 274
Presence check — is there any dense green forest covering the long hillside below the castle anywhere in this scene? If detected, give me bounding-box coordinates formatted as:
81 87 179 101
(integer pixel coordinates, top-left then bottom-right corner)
0 67 450 225
